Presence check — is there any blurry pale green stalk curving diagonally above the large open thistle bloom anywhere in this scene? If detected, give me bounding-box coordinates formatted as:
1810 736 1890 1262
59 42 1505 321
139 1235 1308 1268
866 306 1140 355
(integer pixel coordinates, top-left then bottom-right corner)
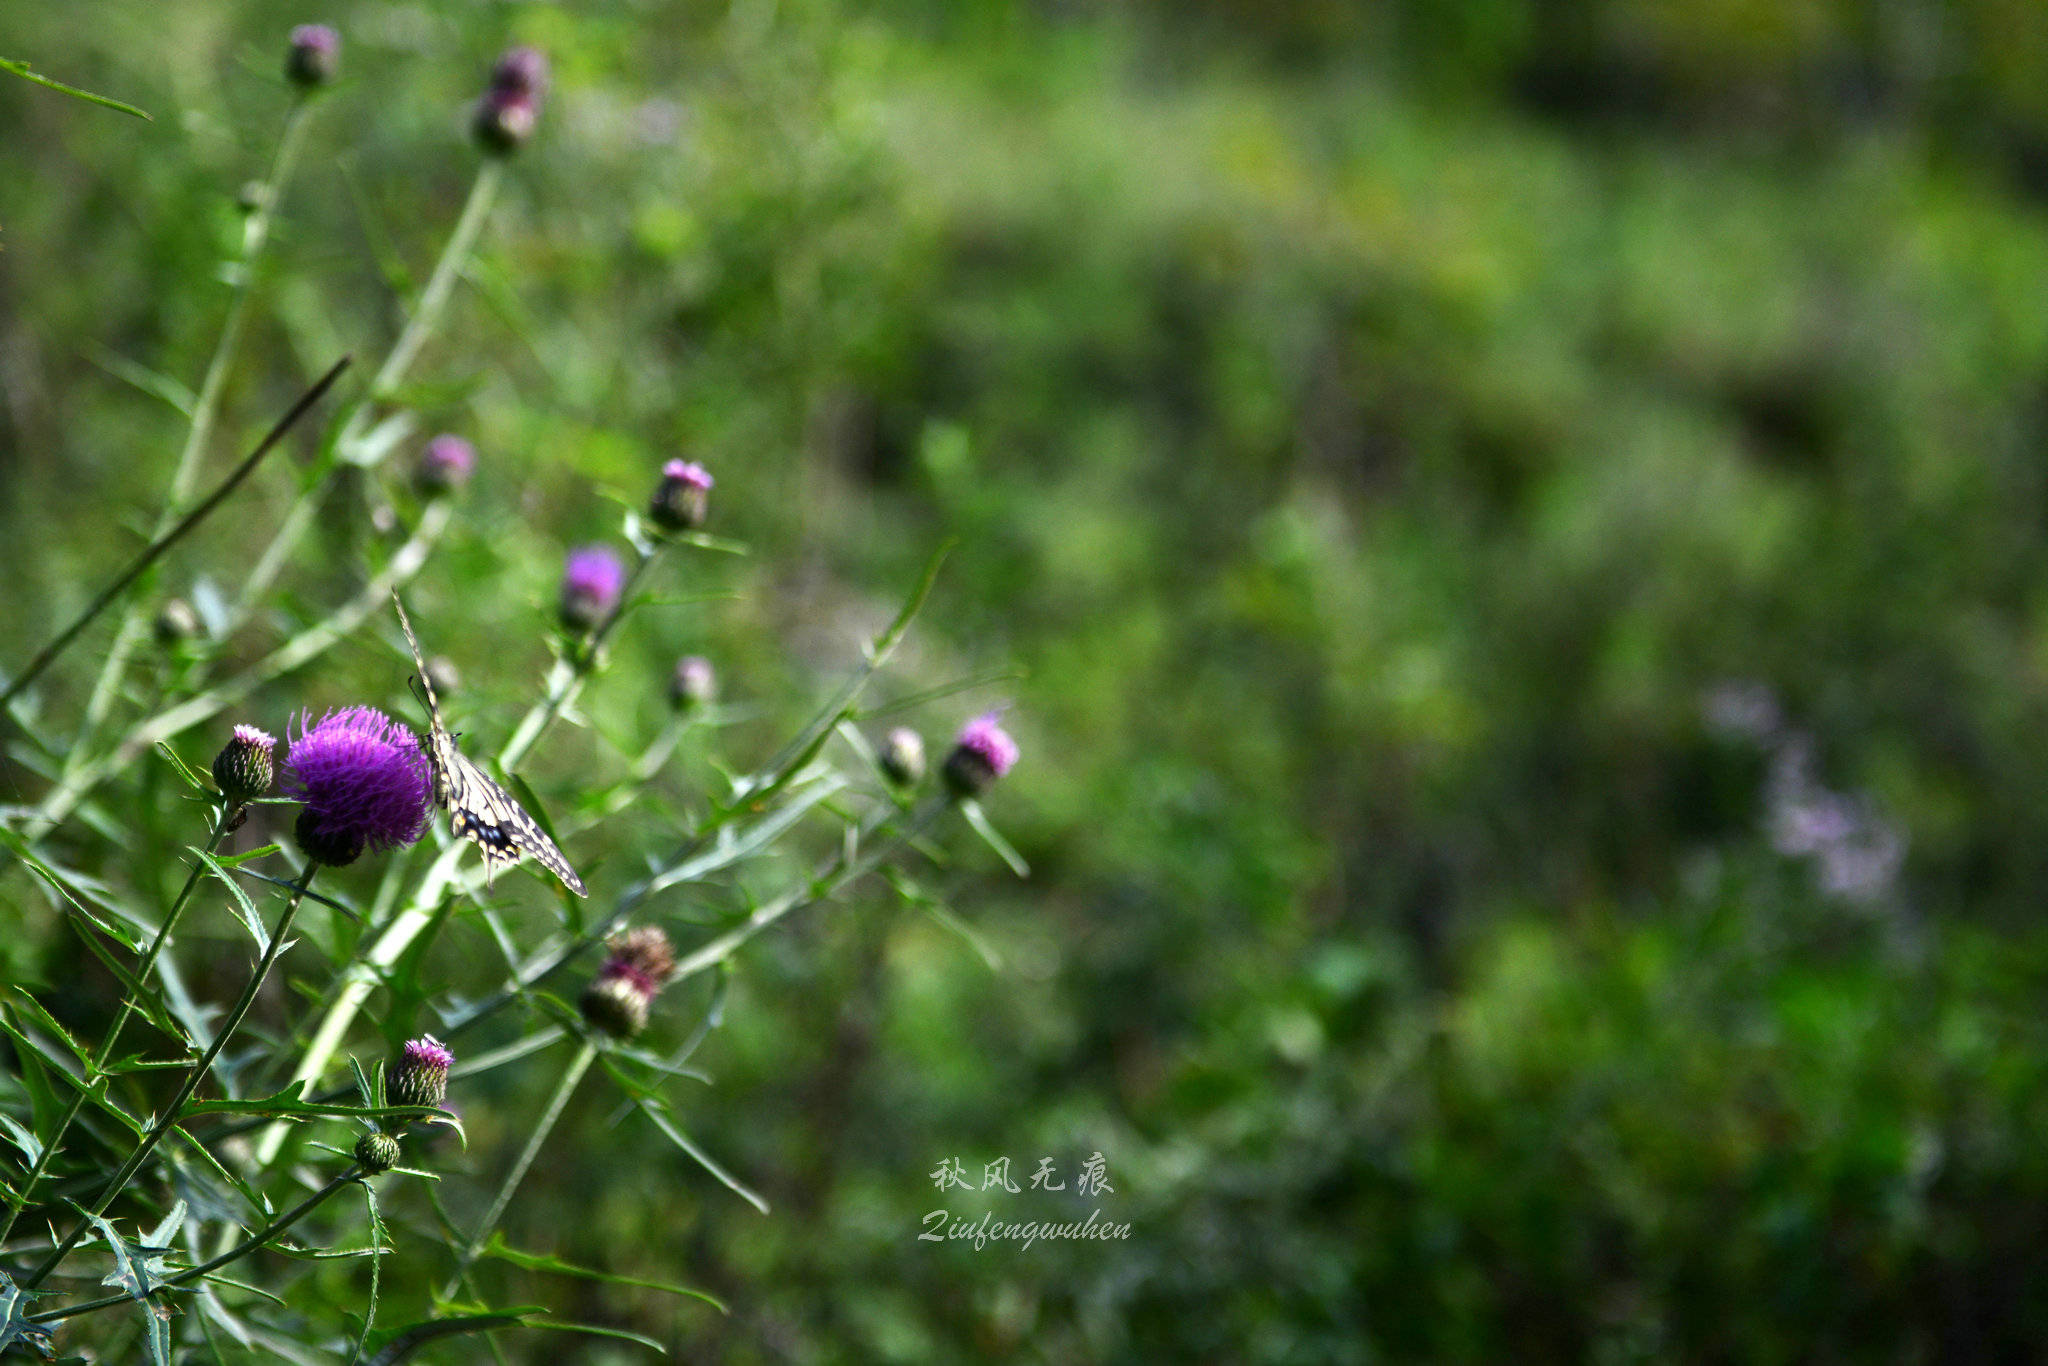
27 500 453 838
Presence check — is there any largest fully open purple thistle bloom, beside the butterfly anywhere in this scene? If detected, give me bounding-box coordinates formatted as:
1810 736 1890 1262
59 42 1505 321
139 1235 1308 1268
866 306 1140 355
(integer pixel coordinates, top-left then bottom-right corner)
281 707 428 866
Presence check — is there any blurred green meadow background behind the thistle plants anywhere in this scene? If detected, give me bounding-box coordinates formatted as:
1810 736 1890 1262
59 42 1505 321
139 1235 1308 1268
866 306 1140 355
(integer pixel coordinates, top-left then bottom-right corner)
12 0 2048 1362
